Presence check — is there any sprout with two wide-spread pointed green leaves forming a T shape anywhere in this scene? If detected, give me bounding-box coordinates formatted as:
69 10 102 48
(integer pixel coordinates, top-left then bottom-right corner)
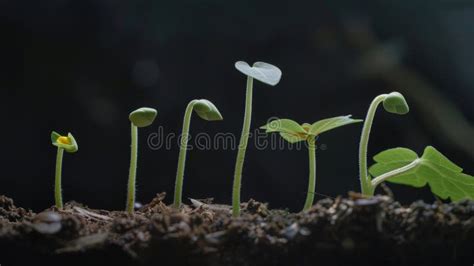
261 115 362 211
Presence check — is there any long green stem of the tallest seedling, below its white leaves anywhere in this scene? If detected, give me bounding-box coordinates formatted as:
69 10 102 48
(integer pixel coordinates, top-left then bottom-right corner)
232 77 253 217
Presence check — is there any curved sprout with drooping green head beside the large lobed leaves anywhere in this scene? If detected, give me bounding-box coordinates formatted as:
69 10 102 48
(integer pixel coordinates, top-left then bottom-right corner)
359 92 410 196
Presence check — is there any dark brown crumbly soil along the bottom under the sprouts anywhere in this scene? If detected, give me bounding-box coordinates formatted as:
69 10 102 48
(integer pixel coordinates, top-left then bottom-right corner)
0 193 474 266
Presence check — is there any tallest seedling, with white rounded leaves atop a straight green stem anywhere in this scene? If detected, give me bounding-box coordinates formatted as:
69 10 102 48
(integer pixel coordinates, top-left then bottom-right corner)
232 61 281 217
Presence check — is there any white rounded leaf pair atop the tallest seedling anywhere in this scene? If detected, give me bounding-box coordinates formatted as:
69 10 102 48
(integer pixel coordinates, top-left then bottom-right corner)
235 61 281 86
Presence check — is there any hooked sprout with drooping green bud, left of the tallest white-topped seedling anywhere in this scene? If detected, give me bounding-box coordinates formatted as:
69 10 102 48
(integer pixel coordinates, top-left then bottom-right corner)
173 99 222 208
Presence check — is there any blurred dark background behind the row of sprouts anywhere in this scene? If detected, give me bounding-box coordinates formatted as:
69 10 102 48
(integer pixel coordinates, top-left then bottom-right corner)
0 0 474 210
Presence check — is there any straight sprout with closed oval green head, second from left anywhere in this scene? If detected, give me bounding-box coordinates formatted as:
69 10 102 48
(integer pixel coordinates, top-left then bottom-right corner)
126 107 156 213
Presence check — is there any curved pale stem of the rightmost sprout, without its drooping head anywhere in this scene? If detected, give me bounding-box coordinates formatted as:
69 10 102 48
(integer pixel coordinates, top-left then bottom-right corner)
359 94 387 196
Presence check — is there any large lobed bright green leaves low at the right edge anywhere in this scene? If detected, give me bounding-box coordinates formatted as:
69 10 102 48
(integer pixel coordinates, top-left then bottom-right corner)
369 146 474 201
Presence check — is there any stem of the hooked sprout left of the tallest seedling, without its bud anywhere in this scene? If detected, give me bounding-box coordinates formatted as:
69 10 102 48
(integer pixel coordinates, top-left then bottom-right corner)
173 100 196 208
